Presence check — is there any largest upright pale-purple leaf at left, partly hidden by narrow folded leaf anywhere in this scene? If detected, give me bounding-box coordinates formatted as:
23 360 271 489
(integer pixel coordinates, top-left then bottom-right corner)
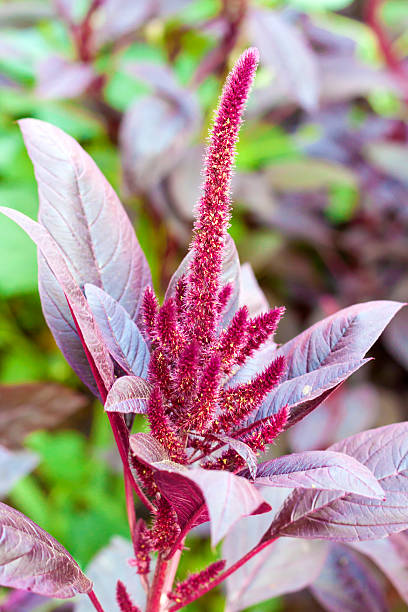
20 119 151 389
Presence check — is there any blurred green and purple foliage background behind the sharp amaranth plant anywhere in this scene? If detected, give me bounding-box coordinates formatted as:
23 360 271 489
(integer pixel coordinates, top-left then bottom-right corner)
0 0 408 612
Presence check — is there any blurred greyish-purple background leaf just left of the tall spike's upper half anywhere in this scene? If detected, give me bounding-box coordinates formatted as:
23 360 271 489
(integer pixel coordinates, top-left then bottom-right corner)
119 75 199 193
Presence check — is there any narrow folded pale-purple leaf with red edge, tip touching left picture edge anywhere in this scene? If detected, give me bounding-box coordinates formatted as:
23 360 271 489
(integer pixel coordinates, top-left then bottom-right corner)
0 207 114 389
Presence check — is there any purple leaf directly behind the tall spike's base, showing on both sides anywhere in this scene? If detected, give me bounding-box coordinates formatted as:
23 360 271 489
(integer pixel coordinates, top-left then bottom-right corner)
164 234 241 327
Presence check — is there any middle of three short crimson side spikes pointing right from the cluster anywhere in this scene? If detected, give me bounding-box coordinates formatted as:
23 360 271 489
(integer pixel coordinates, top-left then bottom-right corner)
218 357 285 432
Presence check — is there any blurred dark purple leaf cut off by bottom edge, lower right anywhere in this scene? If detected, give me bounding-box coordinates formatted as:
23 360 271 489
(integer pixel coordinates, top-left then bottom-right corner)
311 544 389 612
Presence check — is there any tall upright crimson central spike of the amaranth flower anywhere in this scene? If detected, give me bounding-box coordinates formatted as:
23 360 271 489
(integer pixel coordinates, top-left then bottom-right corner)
185 48 259 345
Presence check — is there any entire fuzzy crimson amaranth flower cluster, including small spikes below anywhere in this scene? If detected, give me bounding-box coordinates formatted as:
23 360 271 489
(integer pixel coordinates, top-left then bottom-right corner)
121 49 287 610
